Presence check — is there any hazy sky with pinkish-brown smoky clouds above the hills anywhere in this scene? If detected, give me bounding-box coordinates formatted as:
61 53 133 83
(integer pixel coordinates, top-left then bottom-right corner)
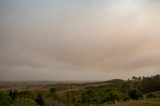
0 0 160 81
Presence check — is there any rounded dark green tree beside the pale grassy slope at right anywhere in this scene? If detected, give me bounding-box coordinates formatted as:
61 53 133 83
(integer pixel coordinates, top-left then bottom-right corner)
129 88 142 100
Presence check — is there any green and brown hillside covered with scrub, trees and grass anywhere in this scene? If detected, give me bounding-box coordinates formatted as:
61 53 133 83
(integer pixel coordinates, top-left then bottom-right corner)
0 75 160 106
